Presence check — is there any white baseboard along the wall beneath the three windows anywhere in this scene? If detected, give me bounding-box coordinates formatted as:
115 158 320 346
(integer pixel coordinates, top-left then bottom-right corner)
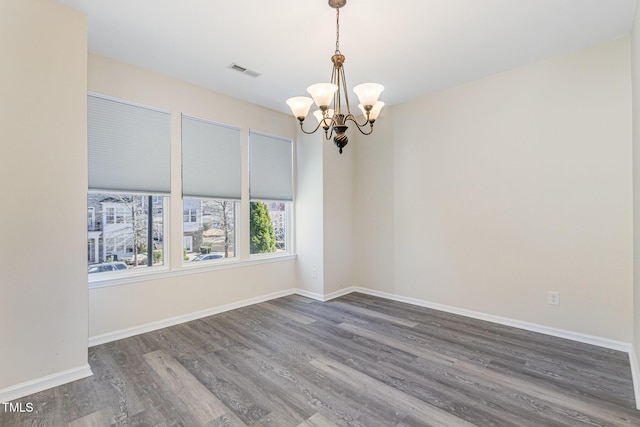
89 289 297 347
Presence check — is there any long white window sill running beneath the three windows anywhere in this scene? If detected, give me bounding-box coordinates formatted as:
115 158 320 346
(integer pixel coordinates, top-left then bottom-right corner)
89 254 297 290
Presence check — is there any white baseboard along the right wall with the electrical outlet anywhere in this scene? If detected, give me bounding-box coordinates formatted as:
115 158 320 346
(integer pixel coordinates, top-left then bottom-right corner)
353 287 633 353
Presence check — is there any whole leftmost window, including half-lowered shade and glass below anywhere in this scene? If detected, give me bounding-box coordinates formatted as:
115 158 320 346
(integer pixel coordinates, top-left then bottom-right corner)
87 94 171 278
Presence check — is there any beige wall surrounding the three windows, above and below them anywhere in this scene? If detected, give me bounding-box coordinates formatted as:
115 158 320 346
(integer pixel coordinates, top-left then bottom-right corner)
89 55 296 337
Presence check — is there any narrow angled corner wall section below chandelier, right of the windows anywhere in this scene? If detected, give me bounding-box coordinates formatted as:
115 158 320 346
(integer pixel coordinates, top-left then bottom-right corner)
296 129 358 298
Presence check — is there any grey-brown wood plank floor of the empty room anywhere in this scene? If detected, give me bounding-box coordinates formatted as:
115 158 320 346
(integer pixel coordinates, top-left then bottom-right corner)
0 293 640 427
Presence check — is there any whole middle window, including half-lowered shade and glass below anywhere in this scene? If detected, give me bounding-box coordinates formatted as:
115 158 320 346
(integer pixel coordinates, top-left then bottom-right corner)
182 115 242 265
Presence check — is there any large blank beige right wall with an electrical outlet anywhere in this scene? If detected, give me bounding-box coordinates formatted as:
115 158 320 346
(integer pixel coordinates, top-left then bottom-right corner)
357 39 633 342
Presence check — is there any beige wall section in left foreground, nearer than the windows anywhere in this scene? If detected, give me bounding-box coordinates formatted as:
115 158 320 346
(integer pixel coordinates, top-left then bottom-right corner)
0 0 88 392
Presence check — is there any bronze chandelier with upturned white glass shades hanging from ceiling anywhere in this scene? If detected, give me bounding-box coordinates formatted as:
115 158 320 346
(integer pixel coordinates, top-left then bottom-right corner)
287 0 384 154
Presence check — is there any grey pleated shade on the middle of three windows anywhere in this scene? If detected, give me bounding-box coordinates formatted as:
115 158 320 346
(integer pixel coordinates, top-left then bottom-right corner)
182 116 242 200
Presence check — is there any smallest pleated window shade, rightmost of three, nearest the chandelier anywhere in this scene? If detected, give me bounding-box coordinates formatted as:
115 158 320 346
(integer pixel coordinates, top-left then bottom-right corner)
249 132 293 201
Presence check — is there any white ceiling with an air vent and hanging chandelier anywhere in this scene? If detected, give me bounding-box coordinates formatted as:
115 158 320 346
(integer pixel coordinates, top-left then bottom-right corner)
53 0 637 112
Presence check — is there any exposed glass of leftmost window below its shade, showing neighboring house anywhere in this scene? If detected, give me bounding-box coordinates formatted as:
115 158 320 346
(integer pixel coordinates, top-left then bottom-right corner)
88 192 165 272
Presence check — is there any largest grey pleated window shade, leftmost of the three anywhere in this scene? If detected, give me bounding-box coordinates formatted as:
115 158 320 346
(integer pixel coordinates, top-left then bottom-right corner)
87 95 171 194
